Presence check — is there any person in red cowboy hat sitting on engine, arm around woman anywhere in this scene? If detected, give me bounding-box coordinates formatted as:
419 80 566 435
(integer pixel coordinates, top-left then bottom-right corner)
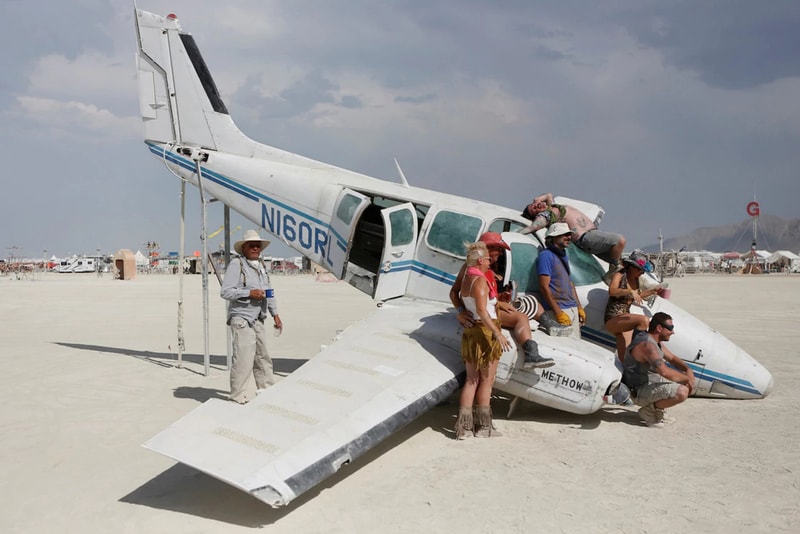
450 232 556 369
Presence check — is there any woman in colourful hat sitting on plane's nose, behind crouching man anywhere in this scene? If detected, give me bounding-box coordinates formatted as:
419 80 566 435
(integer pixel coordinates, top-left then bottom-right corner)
603 253 660 361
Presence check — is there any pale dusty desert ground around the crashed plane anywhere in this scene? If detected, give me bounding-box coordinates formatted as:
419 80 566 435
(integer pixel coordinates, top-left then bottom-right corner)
0 274 800 534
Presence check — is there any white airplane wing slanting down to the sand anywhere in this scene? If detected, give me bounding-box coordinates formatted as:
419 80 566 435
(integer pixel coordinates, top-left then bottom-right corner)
143 299 464 507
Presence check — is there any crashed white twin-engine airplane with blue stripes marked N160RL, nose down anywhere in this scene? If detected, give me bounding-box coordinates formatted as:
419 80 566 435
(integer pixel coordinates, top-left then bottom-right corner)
136 10 773 506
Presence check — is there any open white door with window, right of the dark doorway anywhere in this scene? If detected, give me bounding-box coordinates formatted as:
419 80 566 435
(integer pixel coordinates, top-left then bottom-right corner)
372 202 417 300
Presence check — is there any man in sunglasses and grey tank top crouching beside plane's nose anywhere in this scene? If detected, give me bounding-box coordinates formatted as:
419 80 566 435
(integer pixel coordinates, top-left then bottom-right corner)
622 312 695 428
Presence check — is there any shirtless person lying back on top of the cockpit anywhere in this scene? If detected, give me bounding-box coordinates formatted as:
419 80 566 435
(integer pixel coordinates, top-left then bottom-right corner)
520 193 625 284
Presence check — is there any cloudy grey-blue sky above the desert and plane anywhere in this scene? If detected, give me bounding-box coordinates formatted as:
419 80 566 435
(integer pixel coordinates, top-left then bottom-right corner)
0 0 800 257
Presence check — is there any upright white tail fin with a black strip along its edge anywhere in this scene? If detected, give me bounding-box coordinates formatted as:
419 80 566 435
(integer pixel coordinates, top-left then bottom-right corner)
136 9 257 156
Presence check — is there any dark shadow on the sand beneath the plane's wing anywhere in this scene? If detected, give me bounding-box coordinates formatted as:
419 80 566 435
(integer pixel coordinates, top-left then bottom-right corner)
119 410 428 528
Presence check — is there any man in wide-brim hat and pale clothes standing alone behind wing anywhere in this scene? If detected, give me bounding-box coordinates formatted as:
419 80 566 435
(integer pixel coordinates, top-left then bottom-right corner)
220 230 283 404
